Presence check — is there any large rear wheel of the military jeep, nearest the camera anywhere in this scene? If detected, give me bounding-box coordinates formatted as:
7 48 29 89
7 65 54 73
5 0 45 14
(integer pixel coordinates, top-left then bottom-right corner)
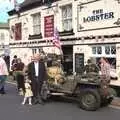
79 89 101 111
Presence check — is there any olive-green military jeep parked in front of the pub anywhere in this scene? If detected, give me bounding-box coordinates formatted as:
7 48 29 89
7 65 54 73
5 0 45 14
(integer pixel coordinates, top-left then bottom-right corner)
43 71 113 111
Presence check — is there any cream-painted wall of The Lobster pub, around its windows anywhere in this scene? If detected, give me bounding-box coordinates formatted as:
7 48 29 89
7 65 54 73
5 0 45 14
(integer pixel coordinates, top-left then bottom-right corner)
9 0 120 86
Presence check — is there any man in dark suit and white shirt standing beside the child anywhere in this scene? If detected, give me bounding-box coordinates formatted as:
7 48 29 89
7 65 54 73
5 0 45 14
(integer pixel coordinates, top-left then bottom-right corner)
27 54 47 104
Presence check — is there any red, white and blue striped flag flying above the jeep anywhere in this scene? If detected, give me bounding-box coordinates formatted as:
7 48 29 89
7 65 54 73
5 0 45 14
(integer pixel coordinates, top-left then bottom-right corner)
52 27 61 49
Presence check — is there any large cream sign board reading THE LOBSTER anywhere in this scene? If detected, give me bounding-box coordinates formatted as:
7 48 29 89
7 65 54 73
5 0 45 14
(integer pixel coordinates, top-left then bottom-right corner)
78 0 120 31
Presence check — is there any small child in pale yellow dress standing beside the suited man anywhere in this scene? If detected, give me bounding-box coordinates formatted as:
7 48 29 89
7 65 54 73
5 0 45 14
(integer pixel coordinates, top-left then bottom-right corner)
22 75 33 105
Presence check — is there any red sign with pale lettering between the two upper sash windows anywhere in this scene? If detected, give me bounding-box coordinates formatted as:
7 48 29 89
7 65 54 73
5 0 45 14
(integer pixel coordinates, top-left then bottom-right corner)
44 15 54 37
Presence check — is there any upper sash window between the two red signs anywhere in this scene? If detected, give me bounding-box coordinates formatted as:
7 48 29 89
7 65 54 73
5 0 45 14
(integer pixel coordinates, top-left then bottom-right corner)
32 13 41 35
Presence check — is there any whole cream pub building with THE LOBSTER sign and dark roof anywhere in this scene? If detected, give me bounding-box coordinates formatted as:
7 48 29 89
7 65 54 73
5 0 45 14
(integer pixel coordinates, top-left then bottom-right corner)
8 0 120 88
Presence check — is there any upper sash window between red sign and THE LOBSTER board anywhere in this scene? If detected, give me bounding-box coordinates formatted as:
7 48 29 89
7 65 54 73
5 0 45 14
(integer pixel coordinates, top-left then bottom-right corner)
62 4 72 31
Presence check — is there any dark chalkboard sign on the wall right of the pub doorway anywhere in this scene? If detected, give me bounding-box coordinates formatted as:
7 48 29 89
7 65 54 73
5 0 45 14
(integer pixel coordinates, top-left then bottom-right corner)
75 53 84 74
